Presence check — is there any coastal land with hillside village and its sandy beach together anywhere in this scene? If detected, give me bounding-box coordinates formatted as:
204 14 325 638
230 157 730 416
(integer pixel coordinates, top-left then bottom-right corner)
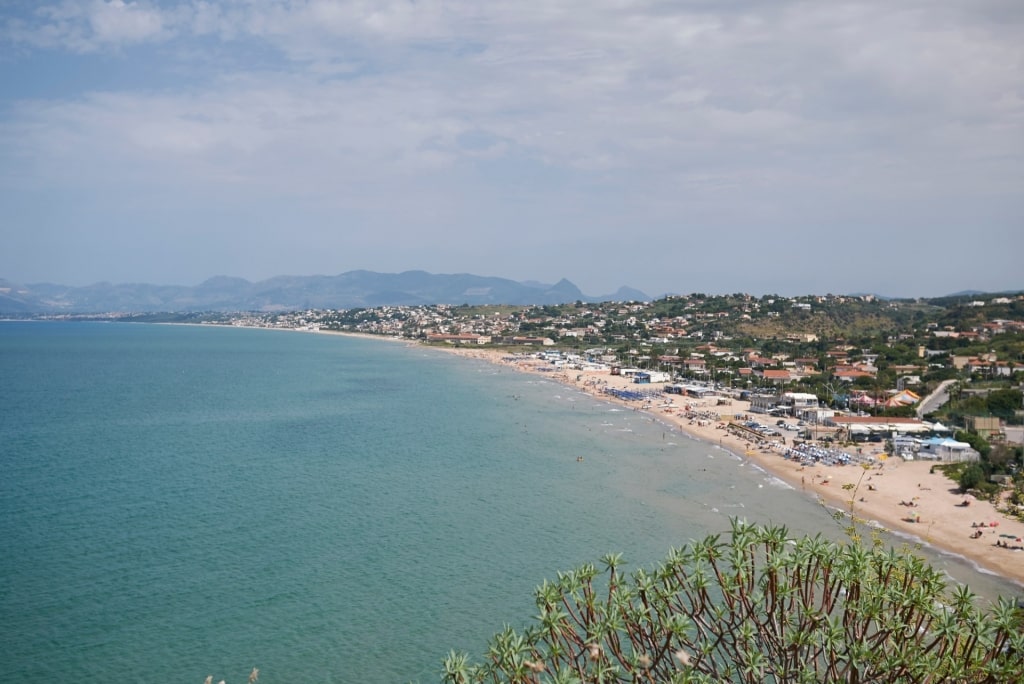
112 293 1024 583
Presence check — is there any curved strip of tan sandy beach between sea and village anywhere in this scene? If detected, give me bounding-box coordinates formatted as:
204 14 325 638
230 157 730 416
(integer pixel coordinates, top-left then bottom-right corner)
451 348 1024 585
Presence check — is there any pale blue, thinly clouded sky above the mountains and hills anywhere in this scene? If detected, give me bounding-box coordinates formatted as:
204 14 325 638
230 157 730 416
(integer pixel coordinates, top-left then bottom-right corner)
0 0 1024 297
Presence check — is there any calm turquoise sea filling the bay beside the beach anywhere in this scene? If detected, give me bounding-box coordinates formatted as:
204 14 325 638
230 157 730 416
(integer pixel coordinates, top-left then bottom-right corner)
0 322 1020 684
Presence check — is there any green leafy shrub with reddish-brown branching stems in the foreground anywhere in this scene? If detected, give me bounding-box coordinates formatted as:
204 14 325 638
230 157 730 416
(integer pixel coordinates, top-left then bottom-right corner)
443 520 1024 684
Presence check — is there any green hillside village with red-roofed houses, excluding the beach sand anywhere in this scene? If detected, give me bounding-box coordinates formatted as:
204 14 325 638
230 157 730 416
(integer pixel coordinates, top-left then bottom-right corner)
188 294 1024 454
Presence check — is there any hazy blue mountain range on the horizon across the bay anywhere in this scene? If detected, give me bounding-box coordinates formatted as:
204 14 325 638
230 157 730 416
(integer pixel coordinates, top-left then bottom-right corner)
0 270 650 315
